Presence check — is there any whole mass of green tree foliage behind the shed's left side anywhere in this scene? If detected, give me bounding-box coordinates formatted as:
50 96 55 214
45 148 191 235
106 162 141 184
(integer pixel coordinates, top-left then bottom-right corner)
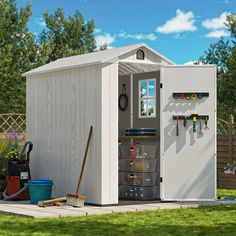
0 0 96 113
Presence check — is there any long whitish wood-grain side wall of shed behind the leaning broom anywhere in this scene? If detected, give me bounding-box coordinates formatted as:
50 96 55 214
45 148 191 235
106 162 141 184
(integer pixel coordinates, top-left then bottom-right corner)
27 65 102 204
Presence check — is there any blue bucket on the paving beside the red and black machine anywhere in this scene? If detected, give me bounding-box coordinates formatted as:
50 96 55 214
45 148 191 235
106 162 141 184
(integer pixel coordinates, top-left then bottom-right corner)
28 179 53 204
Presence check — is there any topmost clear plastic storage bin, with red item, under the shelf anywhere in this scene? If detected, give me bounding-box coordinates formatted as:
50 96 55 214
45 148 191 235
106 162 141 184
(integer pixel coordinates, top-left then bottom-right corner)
119 145 157 158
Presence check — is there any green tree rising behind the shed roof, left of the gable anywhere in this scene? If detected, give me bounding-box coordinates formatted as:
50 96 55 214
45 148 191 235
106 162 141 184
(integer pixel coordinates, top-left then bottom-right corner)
39 8 96 64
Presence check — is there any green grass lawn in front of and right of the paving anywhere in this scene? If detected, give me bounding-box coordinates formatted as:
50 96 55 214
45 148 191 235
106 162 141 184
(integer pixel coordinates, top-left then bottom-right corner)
0 190 236 236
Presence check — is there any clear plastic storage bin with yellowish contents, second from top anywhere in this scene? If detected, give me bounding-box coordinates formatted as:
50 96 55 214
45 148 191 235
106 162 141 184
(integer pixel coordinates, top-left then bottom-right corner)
119 158 157 172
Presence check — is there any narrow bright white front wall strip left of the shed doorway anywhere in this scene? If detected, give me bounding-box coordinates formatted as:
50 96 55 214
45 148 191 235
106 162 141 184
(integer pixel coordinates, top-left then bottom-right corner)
101 63 118 205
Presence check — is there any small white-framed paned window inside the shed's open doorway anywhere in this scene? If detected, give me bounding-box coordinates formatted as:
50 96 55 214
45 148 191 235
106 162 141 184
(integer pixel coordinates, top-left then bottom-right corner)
139 79 156 118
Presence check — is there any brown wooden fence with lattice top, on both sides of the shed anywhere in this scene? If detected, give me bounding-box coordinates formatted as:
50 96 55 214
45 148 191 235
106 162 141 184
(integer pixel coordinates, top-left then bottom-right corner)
0 113 236 189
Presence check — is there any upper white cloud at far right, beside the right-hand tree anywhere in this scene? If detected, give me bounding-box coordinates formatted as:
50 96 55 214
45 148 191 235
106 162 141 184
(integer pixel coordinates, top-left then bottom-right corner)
202 12 229 30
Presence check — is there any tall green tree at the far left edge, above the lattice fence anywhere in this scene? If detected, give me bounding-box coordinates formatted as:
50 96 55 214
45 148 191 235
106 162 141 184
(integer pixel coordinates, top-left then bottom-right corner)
0 0 37 113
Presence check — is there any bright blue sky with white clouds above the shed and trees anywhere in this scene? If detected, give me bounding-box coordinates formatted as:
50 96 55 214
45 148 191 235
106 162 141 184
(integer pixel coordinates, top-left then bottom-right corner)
17 0 236 64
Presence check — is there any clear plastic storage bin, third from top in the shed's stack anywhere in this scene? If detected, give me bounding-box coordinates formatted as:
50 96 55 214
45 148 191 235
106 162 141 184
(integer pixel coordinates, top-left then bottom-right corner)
119 172 157 186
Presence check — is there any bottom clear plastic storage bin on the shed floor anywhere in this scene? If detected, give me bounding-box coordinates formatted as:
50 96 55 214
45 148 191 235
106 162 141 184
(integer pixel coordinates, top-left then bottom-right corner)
120 185 157 200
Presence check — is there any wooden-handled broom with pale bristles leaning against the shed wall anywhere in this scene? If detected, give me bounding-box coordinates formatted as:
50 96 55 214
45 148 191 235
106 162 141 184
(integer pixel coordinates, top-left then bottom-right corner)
66 126 93 207
